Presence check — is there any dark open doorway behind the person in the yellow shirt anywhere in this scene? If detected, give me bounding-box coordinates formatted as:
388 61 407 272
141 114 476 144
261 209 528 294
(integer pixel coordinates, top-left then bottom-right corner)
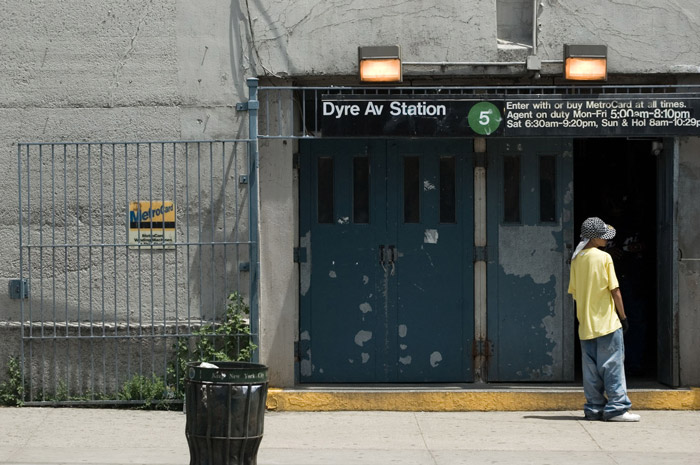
574 138 673 384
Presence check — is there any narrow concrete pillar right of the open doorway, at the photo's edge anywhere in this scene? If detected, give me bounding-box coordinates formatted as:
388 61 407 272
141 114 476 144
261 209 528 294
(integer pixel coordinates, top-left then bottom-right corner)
678 138 700 386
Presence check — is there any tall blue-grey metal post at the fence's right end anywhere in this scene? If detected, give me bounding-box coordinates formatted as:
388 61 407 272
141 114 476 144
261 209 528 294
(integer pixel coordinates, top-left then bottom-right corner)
247 78 260 362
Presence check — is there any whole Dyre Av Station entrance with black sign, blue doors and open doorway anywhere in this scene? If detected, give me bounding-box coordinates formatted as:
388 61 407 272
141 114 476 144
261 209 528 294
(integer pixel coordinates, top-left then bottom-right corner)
254 82 688 386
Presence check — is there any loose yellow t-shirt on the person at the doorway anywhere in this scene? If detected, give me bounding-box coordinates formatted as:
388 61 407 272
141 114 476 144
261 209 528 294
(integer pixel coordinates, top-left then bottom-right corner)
569 247 622 340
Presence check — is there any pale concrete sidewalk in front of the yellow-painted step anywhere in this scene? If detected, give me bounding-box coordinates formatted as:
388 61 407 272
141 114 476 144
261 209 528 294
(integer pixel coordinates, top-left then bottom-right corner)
0 408 700 465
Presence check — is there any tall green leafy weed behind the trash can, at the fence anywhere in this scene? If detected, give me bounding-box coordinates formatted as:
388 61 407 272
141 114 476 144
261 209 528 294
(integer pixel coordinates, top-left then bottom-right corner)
168 292 257 396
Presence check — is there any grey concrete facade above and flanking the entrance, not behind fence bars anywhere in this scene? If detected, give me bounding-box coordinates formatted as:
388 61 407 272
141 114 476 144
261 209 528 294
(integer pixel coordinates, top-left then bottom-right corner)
0 0 700 385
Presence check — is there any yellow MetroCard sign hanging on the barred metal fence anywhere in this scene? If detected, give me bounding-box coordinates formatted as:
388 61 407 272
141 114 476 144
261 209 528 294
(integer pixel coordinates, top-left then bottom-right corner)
129 200 175 249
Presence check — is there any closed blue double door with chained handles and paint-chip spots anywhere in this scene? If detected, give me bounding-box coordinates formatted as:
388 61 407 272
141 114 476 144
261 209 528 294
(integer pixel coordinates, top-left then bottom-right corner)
299 140 473 383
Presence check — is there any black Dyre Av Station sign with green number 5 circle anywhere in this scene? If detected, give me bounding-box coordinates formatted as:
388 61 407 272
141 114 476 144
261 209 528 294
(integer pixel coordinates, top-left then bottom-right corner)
317 94 700 137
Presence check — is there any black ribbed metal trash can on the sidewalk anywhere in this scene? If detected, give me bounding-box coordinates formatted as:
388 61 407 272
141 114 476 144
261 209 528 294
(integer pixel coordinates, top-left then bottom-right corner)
185 362 268 465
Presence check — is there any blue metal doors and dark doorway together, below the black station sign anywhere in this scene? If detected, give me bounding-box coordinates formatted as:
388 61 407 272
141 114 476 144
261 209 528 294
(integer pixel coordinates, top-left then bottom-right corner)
300 138 668 383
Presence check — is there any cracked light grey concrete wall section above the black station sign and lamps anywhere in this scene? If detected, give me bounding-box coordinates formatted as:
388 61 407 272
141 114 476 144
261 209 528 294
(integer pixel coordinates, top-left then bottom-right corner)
250 0 700 79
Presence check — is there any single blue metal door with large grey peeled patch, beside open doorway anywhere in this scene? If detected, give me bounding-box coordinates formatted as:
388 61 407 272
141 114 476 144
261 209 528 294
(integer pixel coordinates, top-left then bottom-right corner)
487 139 574 381
